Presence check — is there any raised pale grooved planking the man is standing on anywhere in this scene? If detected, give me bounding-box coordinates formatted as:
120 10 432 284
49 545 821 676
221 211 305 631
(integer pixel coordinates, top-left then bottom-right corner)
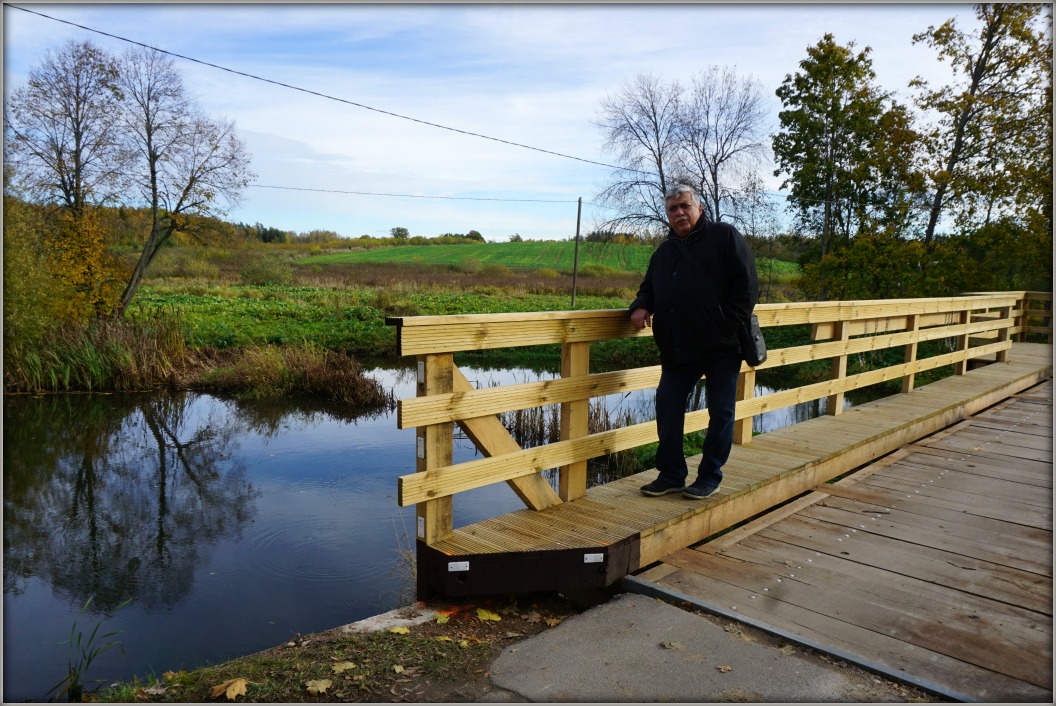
434 344 1051 555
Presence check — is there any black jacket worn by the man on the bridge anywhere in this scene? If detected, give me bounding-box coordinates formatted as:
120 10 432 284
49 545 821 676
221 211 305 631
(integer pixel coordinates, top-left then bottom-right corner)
630 215 759 365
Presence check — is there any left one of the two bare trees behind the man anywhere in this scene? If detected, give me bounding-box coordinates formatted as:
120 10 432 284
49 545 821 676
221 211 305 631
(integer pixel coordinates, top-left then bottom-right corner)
595 75 682 229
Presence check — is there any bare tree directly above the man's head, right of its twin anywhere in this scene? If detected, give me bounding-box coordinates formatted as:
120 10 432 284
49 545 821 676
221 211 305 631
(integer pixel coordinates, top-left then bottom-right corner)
678 66 767 221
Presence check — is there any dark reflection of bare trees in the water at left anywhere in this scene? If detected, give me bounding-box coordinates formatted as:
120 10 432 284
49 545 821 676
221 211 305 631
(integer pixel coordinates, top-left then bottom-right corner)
3 394 258 613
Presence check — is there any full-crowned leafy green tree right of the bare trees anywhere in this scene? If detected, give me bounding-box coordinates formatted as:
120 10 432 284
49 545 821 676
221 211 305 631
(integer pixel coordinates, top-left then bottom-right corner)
773 34 923 299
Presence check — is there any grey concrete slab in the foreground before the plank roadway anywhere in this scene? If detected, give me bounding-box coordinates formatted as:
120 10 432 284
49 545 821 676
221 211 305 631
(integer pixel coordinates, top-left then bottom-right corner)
485 593 908 703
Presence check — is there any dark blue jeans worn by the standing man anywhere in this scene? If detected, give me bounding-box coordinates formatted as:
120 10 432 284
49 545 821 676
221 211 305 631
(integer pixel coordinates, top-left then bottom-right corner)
657 350 740 484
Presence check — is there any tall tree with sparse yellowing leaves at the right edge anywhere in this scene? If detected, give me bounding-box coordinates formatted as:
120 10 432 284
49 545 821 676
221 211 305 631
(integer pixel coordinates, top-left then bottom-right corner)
910 3 1052 251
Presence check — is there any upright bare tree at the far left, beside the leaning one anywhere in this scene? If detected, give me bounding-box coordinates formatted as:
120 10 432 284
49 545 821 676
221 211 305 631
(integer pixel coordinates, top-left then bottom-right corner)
4 40 120 215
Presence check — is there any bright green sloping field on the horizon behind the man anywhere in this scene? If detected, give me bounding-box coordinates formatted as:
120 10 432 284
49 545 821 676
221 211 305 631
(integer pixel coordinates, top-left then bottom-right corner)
298 241 799 274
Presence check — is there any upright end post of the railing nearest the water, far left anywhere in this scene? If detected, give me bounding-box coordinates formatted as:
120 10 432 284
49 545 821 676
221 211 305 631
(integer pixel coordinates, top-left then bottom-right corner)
416 354 454 548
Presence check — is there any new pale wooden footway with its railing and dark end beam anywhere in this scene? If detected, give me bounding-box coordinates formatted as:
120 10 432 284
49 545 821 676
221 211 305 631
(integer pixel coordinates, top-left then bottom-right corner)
389 291 1052 612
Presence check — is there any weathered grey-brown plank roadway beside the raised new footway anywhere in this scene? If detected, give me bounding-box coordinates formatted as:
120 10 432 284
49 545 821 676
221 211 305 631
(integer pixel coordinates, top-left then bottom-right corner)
624 373 1053 703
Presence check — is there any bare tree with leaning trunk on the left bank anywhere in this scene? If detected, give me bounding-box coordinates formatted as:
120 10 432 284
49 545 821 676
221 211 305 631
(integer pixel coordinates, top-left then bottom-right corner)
116 49 254 317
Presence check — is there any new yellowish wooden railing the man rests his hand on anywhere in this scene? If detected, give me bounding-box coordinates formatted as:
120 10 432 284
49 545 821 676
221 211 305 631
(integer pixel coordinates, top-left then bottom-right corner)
386 291 1052 545
